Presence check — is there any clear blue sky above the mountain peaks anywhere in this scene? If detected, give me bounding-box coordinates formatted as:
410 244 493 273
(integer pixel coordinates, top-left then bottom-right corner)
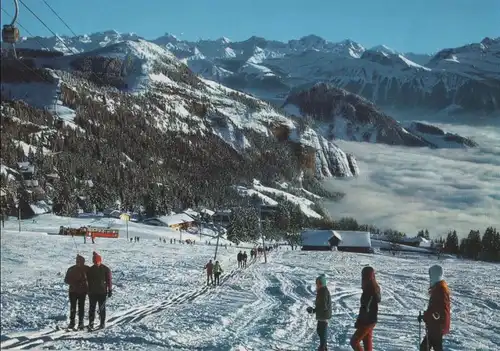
2 0 500 53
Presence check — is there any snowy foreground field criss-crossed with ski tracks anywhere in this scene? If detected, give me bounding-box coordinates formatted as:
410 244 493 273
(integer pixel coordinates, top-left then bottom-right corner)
1 233 500 351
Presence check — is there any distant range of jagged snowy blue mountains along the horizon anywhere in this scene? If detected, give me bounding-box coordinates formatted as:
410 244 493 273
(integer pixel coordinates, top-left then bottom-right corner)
18 31 500 114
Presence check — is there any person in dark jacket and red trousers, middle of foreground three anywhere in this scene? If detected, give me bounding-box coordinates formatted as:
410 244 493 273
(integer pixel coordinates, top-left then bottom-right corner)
351 266 381 351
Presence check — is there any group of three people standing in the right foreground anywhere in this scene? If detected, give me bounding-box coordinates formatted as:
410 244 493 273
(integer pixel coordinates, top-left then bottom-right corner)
307 265 451 351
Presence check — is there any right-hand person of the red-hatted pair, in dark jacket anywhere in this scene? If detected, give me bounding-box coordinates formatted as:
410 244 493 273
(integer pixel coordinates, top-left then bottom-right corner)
87 251 112 330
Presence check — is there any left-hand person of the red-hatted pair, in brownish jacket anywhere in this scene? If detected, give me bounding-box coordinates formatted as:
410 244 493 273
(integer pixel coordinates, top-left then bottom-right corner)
64 255 89 330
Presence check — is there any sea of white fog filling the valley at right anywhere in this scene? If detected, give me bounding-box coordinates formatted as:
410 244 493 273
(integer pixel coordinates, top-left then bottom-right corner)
325 119 500 237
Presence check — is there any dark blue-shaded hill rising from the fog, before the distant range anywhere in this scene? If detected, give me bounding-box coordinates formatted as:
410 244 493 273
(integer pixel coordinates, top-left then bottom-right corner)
284 82 477 148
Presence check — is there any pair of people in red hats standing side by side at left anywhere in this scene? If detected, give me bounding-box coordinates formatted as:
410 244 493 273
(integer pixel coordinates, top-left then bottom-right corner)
64 251 112 330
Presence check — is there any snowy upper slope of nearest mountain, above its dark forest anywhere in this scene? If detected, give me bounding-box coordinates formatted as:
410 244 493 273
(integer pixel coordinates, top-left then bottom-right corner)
2 40 357 177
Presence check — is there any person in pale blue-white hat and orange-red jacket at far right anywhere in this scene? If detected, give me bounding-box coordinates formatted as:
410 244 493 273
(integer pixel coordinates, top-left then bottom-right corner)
418 265 451 351
